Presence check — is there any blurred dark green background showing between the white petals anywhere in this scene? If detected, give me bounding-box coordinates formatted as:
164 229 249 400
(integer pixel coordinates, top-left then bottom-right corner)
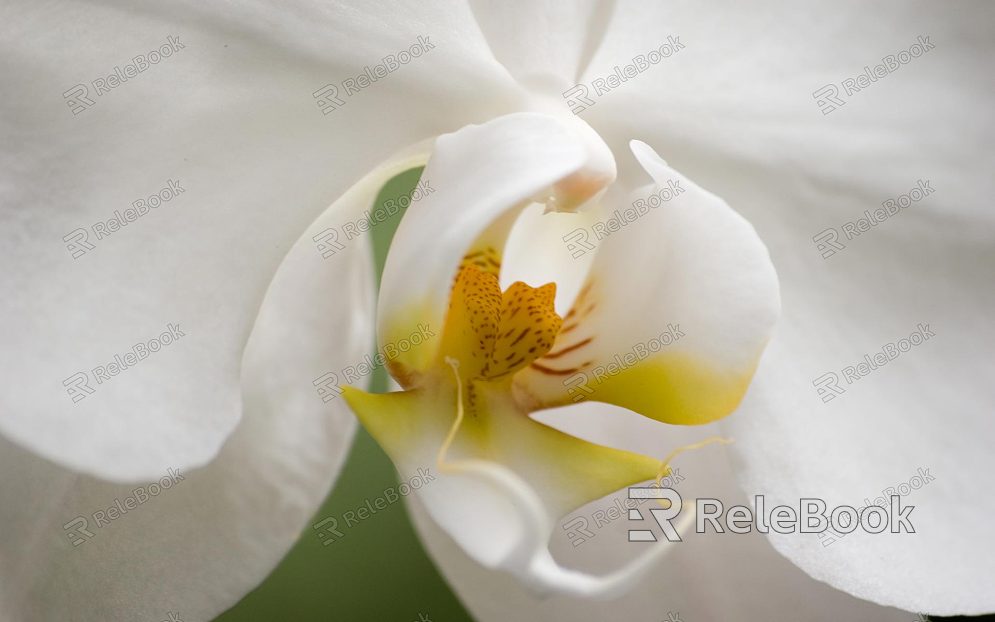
216 169 472 622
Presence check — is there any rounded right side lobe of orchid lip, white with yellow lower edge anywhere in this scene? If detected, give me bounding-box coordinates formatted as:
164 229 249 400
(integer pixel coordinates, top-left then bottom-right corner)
516 142 780 424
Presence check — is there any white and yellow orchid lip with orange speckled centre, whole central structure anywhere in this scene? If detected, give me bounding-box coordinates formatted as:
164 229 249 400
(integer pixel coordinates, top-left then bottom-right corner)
343 108 779 596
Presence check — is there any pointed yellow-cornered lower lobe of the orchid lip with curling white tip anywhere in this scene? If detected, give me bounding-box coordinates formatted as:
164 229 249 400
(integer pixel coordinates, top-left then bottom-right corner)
345 390 680 599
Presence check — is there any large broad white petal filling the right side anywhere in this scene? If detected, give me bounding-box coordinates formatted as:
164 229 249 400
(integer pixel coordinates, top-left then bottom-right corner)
584 3 995 615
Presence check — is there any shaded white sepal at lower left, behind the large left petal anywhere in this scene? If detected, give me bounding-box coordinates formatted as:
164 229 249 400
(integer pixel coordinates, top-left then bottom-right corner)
0 180 379 622
